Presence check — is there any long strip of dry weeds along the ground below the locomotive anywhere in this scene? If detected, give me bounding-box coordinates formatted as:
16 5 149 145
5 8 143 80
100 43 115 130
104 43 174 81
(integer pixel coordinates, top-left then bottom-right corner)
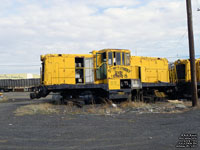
14 100 189 116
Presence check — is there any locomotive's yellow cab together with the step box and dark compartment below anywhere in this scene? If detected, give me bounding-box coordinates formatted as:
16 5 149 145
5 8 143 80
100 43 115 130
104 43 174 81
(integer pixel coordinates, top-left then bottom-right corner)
93 49 141 99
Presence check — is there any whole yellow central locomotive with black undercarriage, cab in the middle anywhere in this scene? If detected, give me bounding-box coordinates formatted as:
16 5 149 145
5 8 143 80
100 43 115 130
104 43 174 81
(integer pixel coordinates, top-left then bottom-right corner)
30 49 175 102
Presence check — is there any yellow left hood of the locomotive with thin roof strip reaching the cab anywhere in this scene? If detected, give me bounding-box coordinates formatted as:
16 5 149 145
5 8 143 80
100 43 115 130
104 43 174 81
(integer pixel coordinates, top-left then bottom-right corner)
41 54 92 85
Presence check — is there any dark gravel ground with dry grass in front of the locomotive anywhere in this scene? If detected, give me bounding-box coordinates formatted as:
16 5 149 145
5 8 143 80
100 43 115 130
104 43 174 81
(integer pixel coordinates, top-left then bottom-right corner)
0 92 200 150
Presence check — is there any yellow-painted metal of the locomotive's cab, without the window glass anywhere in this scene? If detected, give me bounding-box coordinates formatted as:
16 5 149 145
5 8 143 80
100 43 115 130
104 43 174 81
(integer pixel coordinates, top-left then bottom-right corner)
92 49 136 90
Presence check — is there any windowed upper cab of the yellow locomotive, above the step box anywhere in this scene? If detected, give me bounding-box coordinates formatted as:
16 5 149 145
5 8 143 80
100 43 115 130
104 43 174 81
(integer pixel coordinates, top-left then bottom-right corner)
93 49 131 85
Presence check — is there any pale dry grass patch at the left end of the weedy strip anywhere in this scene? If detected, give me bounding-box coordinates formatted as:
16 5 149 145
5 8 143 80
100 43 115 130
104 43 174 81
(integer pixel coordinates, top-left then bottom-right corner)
14 103 59 116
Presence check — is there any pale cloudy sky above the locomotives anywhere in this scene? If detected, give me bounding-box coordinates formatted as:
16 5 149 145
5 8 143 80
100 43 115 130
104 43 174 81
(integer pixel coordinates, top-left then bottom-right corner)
0 0 200 74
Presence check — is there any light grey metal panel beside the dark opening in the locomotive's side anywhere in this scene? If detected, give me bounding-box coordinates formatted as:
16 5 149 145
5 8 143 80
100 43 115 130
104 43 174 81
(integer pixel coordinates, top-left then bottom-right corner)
84 58 94 83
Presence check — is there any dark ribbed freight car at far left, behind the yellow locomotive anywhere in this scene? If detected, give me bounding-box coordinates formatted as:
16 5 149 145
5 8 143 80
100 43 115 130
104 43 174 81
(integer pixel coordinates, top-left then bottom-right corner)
0 78 40 92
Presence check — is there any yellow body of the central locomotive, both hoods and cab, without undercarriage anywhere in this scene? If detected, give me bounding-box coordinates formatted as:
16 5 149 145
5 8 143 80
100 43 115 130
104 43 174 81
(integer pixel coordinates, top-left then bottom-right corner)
41 49 169 90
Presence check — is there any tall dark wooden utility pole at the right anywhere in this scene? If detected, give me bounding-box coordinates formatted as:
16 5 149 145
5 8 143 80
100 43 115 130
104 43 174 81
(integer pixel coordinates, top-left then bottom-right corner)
186 0 199 107
